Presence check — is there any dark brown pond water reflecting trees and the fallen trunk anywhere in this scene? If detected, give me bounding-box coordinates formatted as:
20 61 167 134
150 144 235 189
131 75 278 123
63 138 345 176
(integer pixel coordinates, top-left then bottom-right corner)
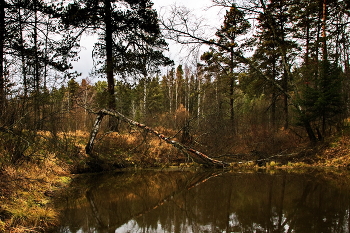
56 168 350 233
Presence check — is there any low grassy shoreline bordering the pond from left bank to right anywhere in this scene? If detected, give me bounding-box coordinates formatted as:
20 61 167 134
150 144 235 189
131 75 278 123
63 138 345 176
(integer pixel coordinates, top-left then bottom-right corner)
0 132 350 232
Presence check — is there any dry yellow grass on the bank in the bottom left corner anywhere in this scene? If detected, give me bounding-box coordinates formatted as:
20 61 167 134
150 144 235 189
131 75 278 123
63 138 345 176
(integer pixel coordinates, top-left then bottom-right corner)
0 157 69 232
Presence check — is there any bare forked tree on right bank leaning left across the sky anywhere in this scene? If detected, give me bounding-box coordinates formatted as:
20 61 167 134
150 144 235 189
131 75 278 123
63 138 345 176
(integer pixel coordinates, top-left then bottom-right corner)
162 0 322 141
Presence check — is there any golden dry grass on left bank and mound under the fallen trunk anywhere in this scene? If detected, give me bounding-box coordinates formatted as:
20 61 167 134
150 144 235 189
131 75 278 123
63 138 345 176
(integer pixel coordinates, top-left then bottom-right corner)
0 128 183 233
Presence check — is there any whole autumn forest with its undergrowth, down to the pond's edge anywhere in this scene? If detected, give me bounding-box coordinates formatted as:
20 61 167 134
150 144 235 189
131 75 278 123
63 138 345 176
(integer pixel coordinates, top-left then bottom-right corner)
0 0 350 231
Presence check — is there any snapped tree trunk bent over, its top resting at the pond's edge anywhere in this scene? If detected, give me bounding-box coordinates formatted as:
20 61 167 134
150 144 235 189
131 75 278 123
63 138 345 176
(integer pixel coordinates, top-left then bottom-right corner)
85 109 229 167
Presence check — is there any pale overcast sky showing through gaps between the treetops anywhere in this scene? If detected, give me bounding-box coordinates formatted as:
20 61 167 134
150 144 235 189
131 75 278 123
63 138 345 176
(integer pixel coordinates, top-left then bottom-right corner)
72 0 225 82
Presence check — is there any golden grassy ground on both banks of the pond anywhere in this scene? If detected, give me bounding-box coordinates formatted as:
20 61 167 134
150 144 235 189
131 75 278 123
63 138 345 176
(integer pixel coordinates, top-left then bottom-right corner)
0 129 350 233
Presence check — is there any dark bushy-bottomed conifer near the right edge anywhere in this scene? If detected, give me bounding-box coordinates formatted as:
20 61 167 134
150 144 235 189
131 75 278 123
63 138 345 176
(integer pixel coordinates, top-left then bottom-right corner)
294 0 345 140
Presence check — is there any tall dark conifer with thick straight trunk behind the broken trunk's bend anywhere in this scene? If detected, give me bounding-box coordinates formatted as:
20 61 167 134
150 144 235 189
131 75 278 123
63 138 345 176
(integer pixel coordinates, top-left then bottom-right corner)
63 0 170 120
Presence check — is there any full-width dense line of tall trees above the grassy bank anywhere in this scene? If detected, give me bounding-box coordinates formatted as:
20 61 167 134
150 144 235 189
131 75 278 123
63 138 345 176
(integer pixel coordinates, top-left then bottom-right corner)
0 0 350 164
